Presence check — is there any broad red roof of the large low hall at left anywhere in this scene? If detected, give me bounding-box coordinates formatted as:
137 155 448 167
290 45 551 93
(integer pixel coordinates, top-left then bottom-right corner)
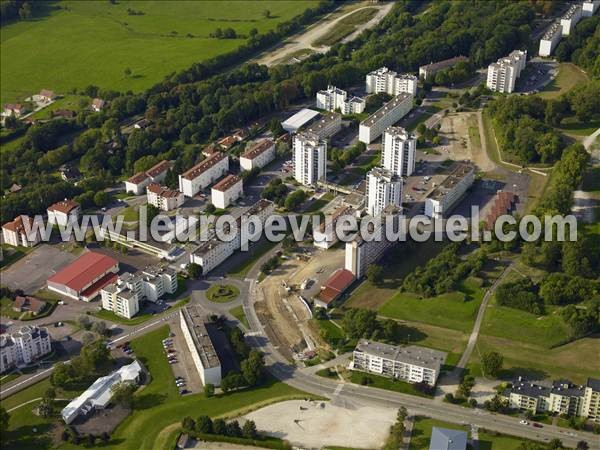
48 252 119 292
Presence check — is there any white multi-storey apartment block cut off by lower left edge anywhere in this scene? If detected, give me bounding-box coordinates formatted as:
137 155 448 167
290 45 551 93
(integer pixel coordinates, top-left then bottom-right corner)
0 325 52 373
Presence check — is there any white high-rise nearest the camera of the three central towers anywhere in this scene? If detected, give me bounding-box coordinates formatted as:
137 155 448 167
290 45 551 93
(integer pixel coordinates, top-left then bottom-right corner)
365 167 402 216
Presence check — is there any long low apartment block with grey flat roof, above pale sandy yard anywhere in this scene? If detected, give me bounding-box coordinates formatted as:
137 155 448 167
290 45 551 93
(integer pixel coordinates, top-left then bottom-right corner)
351 339 448 386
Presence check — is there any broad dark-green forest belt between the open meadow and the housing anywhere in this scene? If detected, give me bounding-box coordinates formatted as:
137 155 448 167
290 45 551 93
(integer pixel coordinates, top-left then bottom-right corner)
0 0 568 222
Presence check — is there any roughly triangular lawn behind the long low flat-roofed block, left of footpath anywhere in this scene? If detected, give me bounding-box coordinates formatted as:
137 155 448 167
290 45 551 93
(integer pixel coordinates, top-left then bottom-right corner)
379 280 484 332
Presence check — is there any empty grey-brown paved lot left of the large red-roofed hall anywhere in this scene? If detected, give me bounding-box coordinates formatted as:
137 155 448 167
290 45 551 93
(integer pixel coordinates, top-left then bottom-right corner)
2 244 77 294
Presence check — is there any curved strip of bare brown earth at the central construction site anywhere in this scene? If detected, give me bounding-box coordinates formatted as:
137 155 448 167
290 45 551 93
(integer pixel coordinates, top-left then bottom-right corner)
255 246 344 360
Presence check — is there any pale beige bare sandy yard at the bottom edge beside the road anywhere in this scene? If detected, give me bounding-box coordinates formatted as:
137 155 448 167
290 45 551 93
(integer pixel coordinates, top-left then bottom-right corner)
245 400 396 448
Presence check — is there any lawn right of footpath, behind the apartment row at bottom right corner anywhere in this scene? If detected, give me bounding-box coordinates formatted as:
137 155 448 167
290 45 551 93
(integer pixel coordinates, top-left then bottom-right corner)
468 334 600 384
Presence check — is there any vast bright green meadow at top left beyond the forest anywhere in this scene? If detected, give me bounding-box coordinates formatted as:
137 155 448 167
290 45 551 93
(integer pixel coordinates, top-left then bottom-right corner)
0 0 318 103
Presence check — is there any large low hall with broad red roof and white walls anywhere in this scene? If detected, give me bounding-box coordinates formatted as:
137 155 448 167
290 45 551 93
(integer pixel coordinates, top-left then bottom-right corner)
48 251 119 302
